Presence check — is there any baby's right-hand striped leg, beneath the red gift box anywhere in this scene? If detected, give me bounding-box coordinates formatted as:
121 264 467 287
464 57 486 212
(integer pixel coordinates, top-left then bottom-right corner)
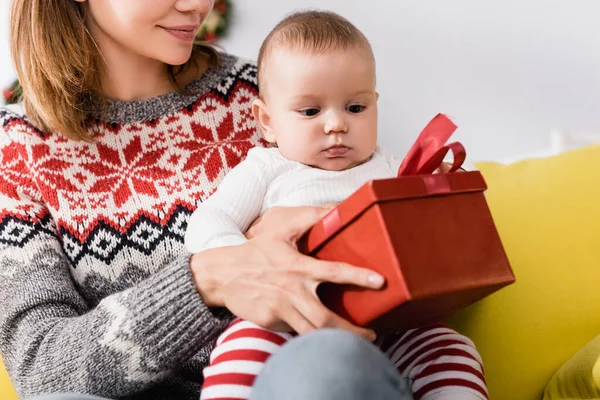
379 324 488 400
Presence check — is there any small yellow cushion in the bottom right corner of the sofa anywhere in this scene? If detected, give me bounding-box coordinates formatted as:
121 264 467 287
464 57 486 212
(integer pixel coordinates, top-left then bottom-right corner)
544 335 600 400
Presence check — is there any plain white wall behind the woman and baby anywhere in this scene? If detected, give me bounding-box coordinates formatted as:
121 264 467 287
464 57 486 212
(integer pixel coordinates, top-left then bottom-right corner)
0 0 600 160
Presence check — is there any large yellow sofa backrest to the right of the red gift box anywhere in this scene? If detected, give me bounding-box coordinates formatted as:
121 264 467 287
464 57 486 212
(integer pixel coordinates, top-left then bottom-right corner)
449 147 600 400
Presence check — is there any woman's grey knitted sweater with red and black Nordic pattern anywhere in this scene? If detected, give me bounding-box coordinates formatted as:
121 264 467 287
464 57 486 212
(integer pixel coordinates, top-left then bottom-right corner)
0 55 264 399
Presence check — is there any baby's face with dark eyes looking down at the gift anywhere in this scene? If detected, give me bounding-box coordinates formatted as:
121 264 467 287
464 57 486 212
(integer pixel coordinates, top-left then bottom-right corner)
263 49 378 171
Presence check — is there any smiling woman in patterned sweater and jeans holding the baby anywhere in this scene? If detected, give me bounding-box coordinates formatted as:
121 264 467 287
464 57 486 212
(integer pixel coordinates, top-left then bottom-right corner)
0 0 407 399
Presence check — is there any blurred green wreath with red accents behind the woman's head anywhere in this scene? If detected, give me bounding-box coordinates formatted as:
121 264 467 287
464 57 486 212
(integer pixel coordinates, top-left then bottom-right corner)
2 0 231 104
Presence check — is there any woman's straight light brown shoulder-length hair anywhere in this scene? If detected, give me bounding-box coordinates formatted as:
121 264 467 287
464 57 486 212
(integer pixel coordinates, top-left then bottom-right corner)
10 0 219 140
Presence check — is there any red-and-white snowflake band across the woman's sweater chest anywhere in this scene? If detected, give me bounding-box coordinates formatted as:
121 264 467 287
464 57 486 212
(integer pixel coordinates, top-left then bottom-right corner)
0 57 266 242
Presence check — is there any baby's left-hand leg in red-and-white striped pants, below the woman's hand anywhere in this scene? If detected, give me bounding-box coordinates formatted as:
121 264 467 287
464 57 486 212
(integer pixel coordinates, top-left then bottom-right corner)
200 319 292 400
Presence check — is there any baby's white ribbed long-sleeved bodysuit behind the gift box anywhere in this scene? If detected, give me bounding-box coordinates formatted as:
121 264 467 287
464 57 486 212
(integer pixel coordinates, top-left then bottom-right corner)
185 148 401 253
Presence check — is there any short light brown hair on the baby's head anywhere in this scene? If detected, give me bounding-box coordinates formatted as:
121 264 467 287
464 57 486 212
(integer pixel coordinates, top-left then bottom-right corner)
258 10 375 91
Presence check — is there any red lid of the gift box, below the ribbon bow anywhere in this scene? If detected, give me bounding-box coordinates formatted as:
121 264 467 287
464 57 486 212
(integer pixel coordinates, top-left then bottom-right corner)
298 171 487 254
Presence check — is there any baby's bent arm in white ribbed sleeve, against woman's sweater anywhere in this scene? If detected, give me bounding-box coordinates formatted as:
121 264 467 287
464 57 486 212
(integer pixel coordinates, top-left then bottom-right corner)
185 151 267 253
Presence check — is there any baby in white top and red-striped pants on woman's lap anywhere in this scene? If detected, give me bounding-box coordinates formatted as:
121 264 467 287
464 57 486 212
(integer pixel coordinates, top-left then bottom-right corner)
185 11 487 399
